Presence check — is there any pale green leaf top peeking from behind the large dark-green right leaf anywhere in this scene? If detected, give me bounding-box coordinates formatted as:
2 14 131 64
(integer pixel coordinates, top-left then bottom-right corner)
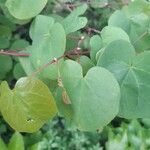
101 26 130 45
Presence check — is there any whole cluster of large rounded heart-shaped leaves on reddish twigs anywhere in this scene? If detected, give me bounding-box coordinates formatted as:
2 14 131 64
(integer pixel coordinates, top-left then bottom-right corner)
0 0 150 132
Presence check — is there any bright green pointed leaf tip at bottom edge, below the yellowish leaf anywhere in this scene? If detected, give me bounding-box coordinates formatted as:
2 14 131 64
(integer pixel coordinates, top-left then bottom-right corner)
8 132 25 150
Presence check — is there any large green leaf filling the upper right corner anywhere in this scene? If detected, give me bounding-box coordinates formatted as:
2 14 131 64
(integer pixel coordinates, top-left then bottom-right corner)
108 0 150 52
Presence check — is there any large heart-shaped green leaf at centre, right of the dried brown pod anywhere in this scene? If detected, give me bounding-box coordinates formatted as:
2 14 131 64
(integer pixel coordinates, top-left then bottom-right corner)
61 60 120 131
